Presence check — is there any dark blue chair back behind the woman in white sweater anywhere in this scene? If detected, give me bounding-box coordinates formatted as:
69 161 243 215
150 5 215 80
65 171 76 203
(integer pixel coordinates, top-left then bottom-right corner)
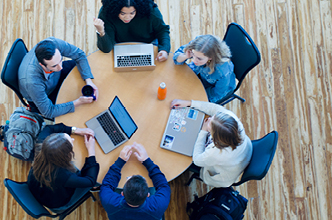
232 131 278 186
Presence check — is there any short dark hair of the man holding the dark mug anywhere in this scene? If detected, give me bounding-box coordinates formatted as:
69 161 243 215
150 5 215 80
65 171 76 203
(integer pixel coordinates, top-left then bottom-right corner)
35 40 57 66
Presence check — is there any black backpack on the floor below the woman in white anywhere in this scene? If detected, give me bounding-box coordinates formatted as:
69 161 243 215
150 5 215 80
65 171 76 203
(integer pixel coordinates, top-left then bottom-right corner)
187 187 248 220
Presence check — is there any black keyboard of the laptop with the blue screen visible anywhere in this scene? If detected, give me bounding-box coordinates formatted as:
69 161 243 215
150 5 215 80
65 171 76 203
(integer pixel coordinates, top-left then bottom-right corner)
97 112 126 146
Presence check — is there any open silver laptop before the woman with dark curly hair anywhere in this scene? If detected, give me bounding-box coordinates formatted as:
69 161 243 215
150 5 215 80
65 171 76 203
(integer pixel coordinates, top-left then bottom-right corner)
114 43 156 71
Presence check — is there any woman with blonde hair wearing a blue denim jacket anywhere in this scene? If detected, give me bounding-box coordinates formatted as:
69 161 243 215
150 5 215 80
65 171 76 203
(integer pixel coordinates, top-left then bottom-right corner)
173 35 236 103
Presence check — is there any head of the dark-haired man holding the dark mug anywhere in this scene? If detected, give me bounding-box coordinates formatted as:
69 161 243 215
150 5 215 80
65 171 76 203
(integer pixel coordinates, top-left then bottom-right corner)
35 40 62 72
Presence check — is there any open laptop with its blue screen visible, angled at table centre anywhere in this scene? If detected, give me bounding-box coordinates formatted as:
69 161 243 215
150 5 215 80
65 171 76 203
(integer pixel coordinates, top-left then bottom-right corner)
85 96 137 154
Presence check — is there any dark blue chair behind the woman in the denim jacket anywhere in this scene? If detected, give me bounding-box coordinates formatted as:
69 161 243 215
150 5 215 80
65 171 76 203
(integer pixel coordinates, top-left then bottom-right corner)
216 23 261 105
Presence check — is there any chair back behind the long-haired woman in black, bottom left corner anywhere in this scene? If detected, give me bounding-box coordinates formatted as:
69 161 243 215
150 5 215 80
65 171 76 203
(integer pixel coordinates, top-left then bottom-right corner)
4 178 56 218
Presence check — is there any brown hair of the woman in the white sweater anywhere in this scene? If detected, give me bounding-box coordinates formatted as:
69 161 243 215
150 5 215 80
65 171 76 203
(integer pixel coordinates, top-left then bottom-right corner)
211 112 243 150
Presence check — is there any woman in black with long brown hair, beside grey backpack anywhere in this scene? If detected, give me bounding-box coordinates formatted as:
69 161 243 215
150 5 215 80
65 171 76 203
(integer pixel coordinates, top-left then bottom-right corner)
27 127 99 209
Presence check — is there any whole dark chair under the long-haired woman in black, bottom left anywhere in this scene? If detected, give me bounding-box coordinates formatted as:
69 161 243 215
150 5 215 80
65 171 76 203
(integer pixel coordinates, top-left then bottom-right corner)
4 178 96 220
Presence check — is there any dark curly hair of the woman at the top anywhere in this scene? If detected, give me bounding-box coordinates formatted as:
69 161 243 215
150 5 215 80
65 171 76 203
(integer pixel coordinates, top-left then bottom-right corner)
101 0 157 19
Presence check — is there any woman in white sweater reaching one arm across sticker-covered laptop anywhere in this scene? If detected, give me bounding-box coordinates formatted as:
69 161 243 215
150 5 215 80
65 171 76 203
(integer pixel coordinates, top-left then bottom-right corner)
171 99 252 187
